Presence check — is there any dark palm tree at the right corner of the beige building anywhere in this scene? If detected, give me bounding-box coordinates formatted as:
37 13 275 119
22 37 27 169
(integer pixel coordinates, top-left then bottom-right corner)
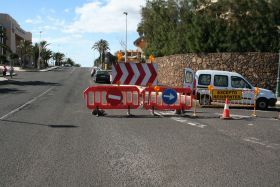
17 40 32 67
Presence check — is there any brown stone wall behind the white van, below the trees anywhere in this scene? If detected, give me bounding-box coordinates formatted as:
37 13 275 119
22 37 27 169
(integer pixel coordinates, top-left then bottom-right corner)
154 53 279 91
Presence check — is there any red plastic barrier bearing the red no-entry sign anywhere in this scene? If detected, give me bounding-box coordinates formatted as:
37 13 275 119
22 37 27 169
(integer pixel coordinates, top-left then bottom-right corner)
84 86 140 113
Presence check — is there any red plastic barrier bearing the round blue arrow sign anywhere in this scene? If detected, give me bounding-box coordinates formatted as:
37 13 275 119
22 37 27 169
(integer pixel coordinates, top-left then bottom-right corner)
141 86 193 110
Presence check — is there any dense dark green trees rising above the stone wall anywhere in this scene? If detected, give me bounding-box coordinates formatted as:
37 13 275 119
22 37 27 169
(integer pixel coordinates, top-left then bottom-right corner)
137 0 280 56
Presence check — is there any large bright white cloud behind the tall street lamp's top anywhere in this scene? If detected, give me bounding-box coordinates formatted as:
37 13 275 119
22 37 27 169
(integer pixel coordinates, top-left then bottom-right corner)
65 0 146 33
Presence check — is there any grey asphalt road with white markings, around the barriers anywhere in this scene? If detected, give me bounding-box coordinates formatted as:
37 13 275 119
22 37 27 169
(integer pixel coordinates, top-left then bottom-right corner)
0 68 280 186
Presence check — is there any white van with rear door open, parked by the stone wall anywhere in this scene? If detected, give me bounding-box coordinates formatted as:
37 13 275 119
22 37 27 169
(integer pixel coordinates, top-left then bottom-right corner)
184 68 277 109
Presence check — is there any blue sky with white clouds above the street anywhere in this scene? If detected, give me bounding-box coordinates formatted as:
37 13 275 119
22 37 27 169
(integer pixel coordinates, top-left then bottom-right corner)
0 0 146 67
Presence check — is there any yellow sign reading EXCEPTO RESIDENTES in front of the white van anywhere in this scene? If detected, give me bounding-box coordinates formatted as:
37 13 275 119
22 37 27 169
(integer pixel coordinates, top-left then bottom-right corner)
212 90 242 100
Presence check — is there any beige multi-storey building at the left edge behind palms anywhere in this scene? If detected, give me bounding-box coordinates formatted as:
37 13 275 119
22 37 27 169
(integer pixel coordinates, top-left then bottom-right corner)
0 13 32 55
